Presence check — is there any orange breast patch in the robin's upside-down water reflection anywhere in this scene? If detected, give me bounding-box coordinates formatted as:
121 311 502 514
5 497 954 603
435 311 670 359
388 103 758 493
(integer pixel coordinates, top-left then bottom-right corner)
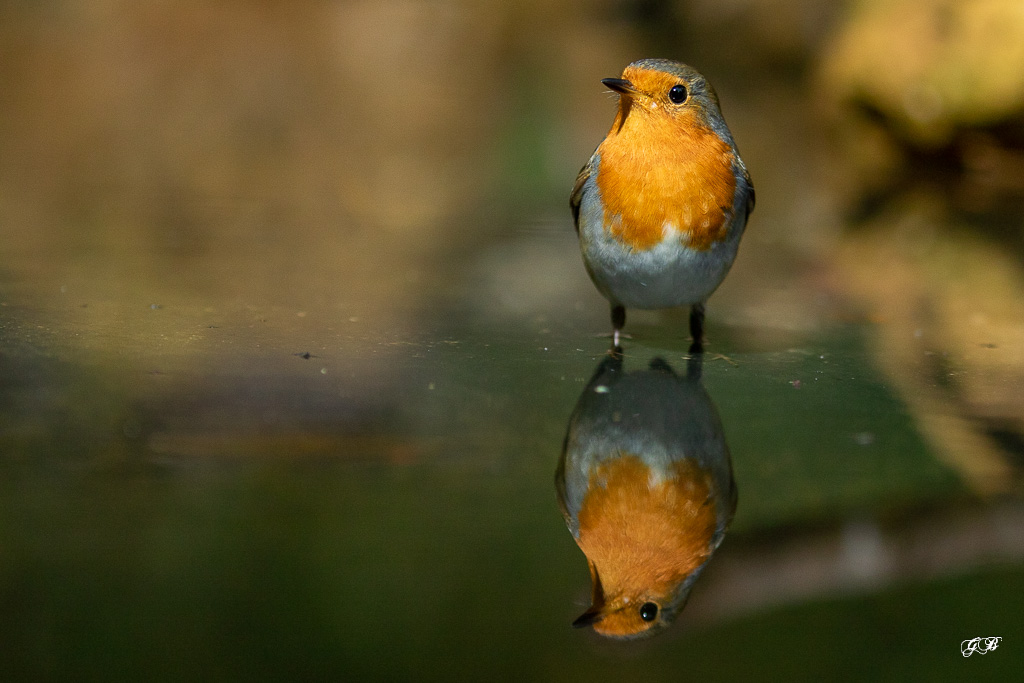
578 455 716 595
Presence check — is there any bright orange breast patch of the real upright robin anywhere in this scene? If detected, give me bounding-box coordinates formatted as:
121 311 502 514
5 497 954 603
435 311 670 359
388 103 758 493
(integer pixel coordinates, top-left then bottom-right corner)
596 102 736 251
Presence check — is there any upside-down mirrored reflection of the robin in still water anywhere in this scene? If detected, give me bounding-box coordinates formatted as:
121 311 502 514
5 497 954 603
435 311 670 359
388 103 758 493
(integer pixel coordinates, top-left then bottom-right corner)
555 349 736 638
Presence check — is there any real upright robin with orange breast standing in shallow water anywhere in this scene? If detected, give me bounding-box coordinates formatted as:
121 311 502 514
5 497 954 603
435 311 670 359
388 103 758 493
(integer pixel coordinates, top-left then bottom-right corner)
569 59 754 352
